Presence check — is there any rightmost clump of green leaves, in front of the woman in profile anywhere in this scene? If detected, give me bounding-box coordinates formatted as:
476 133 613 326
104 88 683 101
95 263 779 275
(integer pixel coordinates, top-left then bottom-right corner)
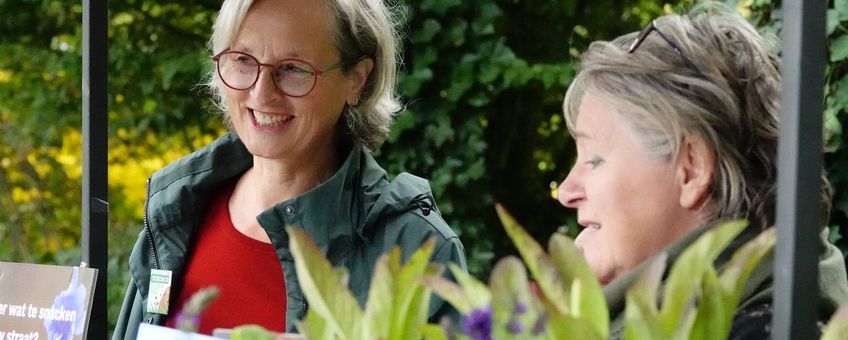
624 221 777 339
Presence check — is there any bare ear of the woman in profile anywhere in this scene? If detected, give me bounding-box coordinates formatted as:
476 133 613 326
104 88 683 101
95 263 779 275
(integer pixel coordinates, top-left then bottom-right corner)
677 136 715 209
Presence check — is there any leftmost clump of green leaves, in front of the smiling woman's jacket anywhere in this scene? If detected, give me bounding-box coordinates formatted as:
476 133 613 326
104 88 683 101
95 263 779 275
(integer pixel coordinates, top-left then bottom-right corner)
287 228 443 340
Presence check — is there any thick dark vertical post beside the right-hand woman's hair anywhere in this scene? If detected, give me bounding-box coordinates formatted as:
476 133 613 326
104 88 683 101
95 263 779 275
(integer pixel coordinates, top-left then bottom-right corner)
772 0 827 340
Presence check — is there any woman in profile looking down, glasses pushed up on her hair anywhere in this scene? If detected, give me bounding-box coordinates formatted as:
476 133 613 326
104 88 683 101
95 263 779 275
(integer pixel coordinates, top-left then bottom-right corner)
558 5 848 339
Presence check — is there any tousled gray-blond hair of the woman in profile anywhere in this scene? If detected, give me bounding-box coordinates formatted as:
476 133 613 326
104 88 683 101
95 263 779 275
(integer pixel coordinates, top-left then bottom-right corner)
563 4 830 227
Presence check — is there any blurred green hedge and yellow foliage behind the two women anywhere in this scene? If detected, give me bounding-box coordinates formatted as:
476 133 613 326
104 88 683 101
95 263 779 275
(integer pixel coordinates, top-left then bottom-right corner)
0 0 848 334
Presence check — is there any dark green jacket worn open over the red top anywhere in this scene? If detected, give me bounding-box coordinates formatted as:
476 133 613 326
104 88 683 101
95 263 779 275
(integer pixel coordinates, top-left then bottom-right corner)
112 133 466 339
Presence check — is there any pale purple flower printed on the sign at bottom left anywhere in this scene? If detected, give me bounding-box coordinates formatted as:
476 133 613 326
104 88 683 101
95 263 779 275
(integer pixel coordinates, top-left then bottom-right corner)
39 267 88 340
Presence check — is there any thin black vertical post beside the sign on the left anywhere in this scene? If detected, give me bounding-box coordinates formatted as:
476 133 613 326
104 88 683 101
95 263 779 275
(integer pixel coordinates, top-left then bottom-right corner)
82 0 109 339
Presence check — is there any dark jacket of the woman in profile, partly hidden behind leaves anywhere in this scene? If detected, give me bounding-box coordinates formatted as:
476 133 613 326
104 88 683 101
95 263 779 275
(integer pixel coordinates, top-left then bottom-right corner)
604 225 848 339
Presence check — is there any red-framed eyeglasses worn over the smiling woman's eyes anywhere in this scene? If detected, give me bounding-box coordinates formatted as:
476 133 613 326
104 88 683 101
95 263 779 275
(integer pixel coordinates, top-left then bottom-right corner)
212 50 342 97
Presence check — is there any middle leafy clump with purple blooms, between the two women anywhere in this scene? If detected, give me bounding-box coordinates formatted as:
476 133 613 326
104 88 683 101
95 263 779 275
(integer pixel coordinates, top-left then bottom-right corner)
425 205 609 340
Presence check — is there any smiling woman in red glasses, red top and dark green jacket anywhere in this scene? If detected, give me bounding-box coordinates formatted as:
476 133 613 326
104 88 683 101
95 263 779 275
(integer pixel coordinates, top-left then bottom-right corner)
113 0 465 339
